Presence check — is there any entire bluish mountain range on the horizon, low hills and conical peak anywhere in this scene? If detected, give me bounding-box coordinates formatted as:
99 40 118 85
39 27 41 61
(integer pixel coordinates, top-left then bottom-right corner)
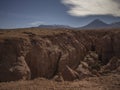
38 19 120 29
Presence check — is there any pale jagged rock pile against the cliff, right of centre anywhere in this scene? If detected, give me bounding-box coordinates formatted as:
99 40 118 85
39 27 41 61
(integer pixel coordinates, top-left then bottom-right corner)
76 51 99 79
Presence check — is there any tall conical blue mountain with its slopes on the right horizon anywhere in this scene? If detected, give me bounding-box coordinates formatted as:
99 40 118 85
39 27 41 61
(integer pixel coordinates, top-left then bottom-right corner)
80 19 120 29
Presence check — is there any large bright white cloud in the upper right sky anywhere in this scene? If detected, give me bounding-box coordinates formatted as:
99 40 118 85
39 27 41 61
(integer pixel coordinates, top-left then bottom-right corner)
62 0 120 16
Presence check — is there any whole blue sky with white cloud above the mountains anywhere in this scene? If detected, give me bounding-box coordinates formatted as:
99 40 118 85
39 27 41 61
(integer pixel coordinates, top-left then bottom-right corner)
0 0 120 29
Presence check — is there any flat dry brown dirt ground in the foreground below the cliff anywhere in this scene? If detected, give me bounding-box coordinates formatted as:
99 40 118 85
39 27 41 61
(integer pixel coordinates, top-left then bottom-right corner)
0 74 120 90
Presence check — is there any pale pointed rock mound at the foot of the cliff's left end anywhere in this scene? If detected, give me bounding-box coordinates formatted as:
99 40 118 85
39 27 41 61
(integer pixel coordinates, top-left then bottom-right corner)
9 56 31 80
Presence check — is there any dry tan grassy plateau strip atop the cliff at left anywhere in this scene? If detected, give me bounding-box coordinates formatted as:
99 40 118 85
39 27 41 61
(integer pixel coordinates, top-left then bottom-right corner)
0 28 68 38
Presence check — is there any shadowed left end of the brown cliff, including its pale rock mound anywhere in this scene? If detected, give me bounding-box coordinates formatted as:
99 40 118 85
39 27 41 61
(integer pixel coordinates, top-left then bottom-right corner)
0 38 31 81
